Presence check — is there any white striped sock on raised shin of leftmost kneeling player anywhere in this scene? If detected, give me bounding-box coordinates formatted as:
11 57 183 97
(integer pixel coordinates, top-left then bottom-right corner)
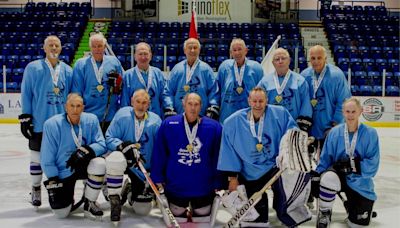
85 157 106 201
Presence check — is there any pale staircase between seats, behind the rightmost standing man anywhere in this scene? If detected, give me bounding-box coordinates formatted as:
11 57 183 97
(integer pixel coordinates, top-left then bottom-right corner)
299 21 335 65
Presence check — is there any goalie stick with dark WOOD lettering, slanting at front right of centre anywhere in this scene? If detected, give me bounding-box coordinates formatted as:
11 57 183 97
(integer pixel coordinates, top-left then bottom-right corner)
224 168 287 228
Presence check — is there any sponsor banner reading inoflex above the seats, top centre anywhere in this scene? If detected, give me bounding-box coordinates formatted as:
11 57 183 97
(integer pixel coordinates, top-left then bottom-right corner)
159 0 251 23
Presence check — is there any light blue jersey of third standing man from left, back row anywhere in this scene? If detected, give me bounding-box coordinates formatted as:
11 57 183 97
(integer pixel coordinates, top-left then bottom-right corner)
121 66 165 118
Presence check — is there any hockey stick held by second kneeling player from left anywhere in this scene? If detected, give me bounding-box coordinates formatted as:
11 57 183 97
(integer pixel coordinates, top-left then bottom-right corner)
137 153 180 228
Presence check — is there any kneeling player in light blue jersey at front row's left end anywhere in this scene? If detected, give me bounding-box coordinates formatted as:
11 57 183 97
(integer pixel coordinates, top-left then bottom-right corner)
40 93 106 218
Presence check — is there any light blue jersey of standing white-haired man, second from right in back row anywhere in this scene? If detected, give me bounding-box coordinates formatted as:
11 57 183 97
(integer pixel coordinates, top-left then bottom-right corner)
258 71 312 120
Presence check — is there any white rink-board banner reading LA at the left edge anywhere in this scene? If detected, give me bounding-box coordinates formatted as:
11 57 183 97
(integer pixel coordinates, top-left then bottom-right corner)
0 93 22 122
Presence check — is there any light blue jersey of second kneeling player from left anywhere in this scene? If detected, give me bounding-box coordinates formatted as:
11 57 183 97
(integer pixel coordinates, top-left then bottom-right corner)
106 107 161 179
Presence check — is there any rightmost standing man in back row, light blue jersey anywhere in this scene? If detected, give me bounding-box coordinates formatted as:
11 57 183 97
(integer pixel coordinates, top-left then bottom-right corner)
301 45 351 153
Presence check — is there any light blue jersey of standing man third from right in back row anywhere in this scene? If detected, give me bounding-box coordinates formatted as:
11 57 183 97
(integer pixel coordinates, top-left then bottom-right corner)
217 59 264 123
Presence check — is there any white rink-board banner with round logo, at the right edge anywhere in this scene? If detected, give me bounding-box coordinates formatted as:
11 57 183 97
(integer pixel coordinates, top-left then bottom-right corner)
357 97 400 124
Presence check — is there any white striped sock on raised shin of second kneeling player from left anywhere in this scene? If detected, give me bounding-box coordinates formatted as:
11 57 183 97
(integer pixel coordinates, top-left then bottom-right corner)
106 151 127 195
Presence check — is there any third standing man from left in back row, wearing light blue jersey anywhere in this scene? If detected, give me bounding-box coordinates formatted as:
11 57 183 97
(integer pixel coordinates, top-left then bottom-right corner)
121 42 165 118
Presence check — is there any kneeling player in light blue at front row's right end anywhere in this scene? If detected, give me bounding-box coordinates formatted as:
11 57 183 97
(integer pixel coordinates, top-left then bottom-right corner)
313 97 380 228
